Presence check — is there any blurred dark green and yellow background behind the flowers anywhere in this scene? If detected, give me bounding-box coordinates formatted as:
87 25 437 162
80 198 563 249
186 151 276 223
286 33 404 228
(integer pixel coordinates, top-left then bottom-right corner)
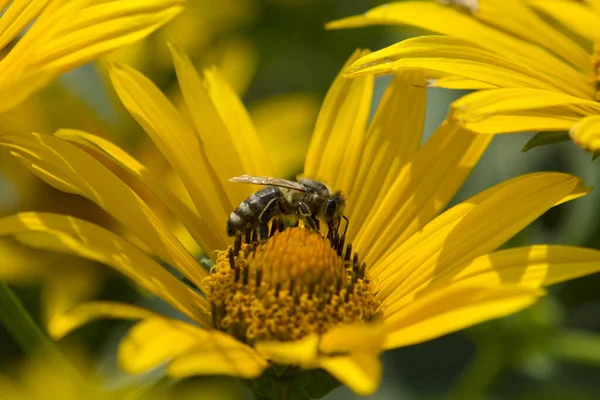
0 0 600 399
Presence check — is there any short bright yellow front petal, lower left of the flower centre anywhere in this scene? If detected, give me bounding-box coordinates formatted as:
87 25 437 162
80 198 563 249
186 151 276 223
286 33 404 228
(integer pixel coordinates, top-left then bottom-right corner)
118 316 205 374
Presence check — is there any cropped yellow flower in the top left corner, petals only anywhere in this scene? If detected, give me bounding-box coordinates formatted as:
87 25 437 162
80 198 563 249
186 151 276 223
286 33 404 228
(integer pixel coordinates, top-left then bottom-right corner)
0 0 183 112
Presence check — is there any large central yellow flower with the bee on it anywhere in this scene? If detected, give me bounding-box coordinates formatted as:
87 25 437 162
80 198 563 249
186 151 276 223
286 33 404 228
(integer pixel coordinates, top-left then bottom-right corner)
0 46 600 395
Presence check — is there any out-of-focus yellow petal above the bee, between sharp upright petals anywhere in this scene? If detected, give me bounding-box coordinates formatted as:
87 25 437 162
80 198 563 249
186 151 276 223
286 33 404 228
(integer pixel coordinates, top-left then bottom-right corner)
250 94 319 178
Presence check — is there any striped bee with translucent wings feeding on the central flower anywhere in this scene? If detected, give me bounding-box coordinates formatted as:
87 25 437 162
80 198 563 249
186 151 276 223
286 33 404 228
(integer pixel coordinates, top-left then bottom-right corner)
227 175 348 236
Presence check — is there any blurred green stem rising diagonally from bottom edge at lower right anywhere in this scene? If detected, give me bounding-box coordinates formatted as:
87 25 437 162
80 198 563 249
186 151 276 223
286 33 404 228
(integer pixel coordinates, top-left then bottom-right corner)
447 342 506 400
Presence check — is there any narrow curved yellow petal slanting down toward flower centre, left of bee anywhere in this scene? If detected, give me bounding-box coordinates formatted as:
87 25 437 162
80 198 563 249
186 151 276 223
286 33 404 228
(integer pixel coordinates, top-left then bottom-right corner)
54 129 219 254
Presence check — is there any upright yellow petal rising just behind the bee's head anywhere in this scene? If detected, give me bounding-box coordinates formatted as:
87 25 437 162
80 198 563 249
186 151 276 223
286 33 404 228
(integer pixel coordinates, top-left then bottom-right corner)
303 51 374 196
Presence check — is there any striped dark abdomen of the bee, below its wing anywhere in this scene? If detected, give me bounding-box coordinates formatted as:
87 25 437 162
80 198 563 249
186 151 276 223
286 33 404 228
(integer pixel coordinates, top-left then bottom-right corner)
227 186 283 236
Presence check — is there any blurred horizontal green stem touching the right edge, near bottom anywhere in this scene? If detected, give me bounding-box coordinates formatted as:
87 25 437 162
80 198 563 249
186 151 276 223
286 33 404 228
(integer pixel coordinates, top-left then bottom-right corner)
548 330 600 366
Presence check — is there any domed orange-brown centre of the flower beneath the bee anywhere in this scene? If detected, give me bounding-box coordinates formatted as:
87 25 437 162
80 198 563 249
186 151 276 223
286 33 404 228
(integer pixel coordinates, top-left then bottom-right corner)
204 222 379 344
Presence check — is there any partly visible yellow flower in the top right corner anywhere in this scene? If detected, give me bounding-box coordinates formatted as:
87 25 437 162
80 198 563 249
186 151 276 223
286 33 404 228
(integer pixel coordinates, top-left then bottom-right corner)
329 0 600 152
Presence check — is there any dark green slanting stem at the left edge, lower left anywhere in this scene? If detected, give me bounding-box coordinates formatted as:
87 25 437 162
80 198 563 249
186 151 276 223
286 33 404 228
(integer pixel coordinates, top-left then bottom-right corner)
0 281 61 357
